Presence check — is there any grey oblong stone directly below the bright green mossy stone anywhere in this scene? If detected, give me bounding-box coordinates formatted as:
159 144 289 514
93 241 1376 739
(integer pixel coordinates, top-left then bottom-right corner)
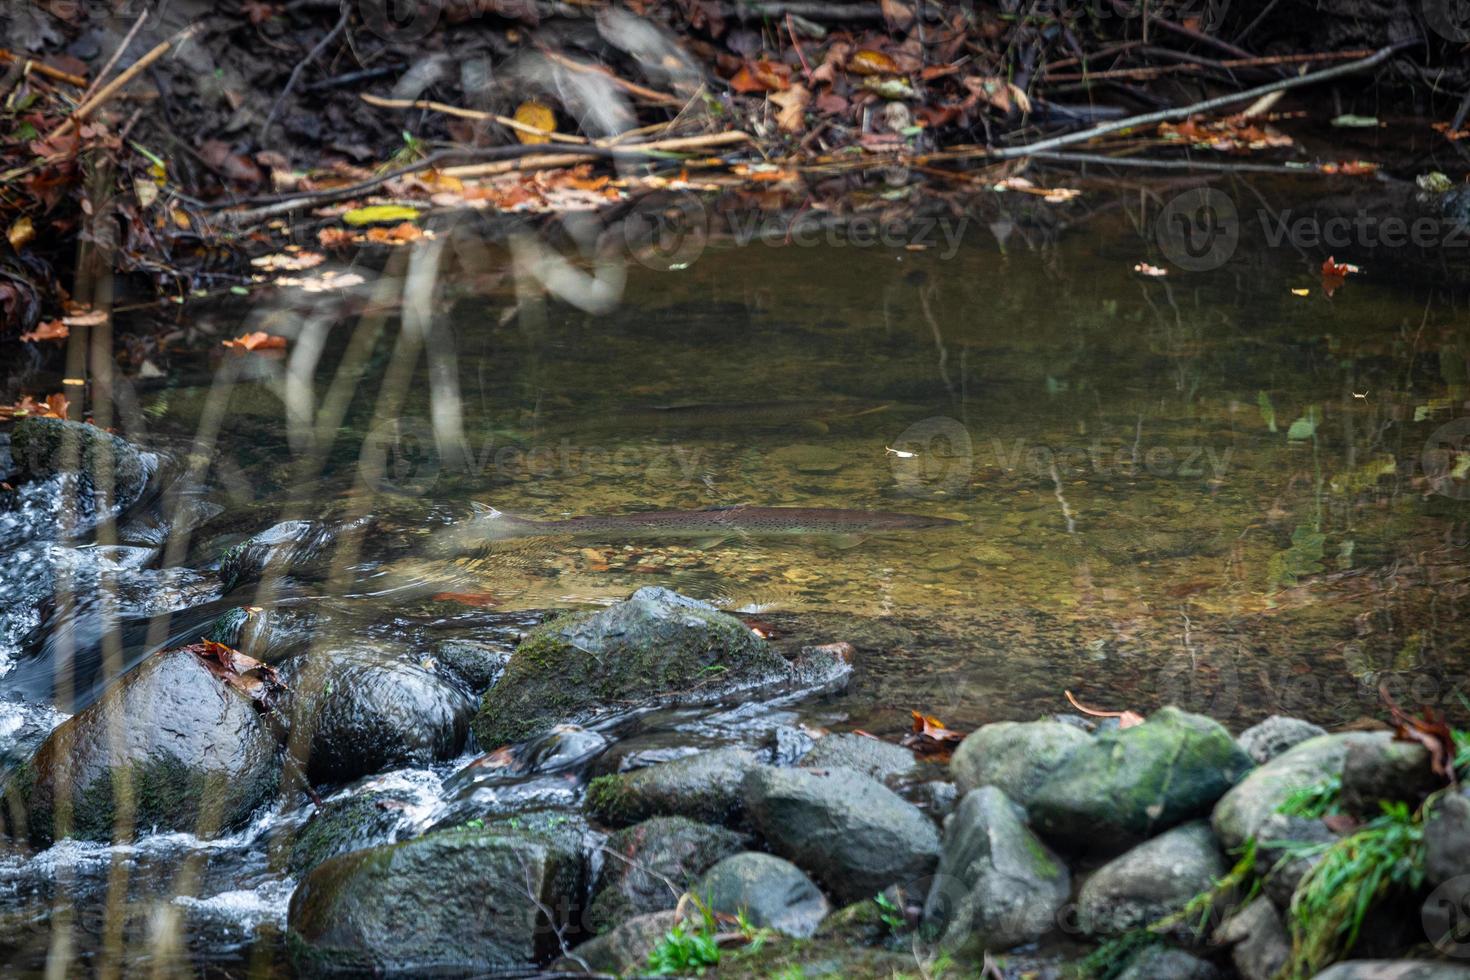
1078 820 1229 936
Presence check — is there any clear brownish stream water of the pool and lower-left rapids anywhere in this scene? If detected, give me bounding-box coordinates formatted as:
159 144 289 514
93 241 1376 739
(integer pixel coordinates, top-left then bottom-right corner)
0 188 1470 974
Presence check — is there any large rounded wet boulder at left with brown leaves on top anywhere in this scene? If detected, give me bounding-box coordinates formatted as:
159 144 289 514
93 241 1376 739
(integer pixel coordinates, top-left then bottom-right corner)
7 649 281 843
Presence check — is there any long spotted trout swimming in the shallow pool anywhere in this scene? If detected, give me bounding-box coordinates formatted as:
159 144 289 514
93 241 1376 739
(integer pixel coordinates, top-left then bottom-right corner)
437 504 960 552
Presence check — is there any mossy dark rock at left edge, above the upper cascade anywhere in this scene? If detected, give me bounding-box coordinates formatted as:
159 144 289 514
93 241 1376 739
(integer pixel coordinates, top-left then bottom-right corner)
10 417 157 530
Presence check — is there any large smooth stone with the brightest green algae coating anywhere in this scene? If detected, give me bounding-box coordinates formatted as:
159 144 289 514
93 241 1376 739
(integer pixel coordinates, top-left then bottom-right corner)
1026 707 1251 849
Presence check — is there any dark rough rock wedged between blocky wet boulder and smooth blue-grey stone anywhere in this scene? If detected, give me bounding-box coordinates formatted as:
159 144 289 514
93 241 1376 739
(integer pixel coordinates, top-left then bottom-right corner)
587 817 745 933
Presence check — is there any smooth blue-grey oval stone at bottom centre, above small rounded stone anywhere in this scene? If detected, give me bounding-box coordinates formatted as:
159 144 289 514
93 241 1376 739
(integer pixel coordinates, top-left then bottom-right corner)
742 765 939 904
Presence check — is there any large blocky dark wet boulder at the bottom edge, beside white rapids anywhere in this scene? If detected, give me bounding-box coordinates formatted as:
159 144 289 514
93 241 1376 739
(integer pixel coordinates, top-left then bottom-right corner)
287 830 582 976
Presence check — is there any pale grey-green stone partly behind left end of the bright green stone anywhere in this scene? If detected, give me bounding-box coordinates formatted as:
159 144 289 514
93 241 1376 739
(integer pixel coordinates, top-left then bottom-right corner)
950 721 1092 807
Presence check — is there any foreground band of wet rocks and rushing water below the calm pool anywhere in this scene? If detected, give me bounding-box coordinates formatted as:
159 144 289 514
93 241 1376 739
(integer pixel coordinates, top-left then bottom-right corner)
0 420 1470 980
